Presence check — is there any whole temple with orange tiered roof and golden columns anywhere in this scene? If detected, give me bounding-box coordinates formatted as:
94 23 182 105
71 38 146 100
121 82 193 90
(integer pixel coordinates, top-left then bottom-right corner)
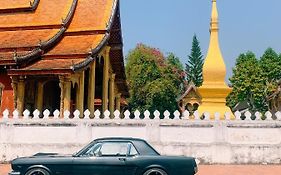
0 0 129 116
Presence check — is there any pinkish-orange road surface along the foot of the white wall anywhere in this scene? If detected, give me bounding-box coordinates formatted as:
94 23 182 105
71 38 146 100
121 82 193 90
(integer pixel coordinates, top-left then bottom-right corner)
0 164 281 175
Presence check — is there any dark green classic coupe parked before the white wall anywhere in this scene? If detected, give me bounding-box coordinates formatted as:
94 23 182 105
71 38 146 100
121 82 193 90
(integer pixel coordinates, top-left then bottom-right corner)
9 138 197 175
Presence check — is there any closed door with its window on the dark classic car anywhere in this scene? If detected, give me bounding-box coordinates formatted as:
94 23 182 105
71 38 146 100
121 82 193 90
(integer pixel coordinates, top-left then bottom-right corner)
73 141 128 175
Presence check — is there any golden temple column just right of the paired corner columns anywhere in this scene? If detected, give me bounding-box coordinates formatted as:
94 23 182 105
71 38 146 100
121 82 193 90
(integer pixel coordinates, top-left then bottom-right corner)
76 71 85 117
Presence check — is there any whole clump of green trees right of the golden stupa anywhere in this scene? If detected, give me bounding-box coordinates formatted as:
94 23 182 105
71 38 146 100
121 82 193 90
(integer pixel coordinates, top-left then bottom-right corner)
227 48 281 111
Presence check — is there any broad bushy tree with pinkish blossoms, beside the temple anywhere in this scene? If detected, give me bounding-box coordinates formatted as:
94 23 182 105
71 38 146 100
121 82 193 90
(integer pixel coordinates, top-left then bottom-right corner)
126 44 184 112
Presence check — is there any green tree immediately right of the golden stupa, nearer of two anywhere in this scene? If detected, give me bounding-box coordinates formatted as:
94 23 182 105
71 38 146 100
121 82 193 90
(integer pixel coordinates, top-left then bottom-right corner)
227 52 268 111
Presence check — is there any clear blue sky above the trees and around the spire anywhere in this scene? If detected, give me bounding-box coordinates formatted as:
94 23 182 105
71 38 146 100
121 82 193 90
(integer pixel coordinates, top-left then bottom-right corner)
121 0 281 78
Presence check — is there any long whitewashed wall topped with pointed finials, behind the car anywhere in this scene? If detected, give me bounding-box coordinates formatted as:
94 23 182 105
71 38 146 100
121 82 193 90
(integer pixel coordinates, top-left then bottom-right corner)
0 110 281 164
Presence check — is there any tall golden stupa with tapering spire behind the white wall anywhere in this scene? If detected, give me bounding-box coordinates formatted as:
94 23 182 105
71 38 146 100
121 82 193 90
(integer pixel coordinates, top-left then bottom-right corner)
198 0 234 119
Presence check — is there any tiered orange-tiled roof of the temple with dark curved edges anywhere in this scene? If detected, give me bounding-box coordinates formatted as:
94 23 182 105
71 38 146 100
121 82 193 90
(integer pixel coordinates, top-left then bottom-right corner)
0 0 128 96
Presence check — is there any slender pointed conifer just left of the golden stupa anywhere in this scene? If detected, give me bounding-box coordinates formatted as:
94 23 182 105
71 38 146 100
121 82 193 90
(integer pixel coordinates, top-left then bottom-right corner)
185 35 204 87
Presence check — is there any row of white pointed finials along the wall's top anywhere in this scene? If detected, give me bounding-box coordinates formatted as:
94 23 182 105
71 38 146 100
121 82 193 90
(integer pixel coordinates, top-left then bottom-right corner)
0 109 281 120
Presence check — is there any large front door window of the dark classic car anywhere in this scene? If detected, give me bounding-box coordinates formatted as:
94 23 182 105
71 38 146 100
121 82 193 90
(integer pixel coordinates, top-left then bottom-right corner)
100 142 128 156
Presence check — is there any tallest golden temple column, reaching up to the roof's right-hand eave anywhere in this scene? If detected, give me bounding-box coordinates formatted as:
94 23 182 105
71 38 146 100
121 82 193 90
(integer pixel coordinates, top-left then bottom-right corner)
102 47 110 112
